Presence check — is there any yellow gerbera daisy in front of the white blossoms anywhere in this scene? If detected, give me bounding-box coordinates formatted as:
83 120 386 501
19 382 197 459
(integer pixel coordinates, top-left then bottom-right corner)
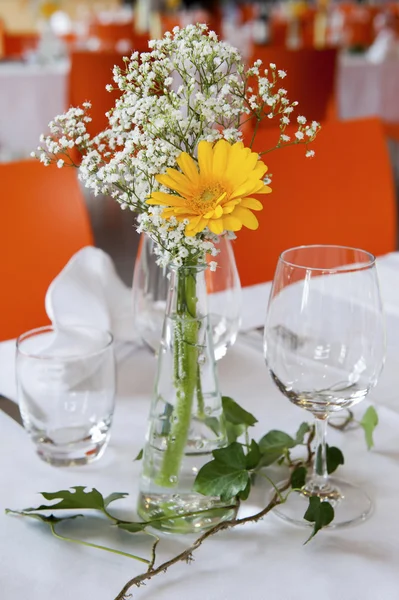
147 140 272 236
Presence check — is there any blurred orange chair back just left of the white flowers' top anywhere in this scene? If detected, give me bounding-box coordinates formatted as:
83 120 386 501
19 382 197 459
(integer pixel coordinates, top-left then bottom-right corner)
68 51 124 135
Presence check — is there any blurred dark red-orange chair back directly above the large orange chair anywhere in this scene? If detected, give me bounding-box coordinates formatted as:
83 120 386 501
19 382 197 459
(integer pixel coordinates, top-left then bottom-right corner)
250 46 337 127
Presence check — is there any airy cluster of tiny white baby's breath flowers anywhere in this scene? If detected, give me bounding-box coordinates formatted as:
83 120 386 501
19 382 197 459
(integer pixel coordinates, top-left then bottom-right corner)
36 25 319 264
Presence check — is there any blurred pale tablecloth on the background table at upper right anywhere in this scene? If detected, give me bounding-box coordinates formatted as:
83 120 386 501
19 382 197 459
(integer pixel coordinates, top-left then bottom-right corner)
337 54 399 123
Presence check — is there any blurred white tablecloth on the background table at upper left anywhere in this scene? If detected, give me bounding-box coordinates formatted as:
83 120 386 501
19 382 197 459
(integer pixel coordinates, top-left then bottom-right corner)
0 62 69 161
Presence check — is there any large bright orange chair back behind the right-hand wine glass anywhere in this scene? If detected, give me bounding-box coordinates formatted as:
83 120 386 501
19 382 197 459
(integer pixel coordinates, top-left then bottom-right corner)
234 119 397 286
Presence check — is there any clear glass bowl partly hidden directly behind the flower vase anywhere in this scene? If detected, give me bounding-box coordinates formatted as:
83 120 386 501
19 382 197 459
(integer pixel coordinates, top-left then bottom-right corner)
133 234 241 360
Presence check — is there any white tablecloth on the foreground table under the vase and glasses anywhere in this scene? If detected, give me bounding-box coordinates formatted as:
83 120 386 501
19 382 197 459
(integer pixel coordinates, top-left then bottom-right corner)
0 254 399 600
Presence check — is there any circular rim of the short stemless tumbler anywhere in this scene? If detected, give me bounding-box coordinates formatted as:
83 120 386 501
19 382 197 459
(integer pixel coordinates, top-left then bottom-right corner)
16 324 114 361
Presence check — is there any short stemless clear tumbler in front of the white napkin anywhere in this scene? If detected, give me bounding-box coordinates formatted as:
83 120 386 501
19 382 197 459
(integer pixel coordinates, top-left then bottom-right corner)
16 326 115 467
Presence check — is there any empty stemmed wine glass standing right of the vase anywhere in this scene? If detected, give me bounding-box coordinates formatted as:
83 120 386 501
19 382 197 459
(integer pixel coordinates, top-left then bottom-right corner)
264 245 385 526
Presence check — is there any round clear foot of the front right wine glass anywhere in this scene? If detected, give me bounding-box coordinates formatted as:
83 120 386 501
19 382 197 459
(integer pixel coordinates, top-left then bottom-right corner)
273 477 373 529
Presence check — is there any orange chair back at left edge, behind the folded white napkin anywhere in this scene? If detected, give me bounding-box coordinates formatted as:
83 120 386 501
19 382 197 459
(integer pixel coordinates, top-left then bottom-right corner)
0 161 93 340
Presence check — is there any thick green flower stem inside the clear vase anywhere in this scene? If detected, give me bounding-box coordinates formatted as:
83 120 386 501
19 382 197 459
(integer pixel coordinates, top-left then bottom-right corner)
156 267 201 487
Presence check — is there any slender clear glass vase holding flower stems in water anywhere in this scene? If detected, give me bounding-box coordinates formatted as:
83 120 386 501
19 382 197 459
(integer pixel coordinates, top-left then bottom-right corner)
138 265 235 533
